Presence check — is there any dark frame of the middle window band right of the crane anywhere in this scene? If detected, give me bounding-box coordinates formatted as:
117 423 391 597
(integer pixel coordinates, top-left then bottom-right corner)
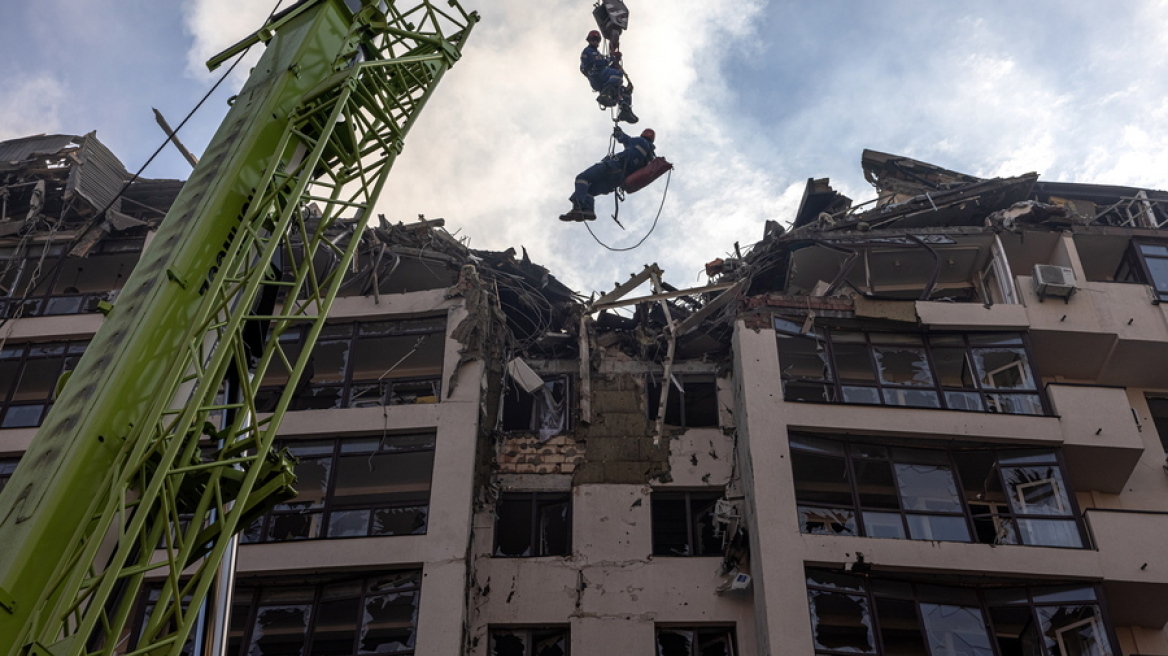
241 432 437 544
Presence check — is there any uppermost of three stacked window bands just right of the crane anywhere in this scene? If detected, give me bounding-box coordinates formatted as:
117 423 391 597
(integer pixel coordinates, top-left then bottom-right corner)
257 316 446 410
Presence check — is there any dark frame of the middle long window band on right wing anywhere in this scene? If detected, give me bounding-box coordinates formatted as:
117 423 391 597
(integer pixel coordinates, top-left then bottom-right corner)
788 432 1092 550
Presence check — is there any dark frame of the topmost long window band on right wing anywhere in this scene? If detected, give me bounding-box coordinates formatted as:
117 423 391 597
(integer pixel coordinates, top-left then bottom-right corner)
774 317 1054 417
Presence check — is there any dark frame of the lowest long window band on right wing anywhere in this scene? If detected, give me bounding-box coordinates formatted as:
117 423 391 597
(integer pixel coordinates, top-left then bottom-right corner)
805 567 1122 656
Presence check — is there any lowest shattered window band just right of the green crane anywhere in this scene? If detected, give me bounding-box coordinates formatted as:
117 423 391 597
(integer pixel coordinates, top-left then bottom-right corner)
228 571 422 656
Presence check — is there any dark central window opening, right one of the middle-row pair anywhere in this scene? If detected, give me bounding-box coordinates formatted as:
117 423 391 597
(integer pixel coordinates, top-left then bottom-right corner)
652 491 724 556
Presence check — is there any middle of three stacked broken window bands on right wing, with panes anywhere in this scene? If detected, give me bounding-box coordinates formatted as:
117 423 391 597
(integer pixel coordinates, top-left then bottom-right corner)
791 434 1087 549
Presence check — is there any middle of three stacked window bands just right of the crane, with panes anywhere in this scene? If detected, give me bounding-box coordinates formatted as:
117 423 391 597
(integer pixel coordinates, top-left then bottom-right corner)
243 433 434 542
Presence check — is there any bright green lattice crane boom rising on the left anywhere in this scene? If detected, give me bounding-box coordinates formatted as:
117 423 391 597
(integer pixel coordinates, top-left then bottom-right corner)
0 0 478 656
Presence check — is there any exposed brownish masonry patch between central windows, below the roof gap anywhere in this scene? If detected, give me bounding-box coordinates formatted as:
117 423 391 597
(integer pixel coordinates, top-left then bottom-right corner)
572 375 669 486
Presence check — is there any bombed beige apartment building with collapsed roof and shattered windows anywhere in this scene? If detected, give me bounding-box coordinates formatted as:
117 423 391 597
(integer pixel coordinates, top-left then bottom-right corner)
0 134 1168 656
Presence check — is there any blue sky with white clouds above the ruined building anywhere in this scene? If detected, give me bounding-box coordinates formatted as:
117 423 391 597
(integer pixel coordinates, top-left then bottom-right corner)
0 0 1168 293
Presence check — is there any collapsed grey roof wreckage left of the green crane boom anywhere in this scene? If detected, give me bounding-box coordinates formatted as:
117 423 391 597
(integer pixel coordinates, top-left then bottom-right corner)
0 132 182 257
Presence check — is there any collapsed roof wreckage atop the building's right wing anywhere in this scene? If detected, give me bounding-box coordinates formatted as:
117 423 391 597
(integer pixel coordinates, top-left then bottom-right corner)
724 151 1168 316
